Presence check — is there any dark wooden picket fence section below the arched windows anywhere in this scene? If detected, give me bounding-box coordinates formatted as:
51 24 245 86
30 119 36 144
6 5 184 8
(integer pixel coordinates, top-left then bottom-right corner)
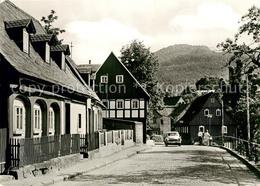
10 134 80 167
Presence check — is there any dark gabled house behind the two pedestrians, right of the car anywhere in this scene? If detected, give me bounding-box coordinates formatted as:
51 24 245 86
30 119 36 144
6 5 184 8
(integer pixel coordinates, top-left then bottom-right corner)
172 92 237 143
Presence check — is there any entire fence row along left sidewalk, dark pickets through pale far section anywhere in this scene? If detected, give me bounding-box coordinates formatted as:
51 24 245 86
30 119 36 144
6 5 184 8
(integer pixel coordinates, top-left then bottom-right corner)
7 130 133 168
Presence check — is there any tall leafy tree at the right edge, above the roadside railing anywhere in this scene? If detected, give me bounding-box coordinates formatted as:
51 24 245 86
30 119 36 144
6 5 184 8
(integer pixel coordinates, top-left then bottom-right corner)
218 6 260 140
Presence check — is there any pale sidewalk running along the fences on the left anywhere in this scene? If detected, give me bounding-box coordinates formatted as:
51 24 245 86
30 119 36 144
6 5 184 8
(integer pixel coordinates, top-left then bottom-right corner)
0 145 150 186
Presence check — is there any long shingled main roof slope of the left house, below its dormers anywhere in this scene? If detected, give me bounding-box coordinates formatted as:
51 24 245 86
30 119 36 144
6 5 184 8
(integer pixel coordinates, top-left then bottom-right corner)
0 0 99 100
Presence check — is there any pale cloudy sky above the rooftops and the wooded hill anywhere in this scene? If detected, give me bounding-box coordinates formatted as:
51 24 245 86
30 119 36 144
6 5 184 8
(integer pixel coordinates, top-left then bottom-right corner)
11 0 260 64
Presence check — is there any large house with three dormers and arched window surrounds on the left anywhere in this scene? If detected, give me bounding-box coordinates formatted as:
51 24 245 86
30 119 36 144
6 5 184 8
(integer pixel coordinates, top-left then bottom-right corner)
0 0 103 171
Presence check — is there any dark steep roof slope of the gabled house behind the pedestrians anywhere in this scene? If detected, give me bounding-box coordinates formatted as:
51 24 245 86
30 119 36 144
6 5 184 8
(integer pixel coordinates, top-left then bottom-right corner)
177 93 213 124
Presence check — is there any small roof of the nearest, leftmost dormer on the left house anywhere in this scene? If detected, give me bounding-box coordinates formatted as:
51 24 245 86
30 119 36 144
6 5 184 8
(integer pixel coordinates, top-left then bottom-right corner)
5 19 36 33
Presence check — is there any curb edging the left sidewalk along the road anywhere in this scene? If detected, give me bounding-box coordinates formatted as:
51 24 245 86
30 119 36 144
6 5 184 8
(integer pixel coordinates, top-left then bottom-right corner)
42 147 149 186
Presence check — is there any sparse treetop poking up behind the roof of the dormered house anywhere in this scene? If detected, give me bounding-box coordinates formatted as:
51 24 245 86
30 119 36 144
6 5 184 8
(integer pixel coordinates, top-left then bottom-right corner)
41 10 65 44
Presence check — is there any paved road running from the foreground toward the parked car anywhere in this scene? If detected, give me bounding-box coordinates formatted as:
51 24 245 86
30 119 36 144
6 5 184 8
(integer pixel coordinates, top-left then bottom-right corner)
54 146 260 186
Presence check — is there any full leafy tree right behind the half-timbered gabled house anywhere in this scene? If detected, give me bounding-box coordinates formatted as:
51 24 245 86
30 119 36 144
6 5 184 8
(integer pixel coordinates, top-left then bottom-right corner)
120 40 163 122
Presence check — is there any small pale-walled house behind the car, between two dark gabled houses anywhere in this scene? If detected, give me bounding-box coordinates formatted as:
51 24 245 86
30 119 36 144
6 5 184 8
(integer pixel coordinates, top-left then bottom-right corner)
150 96 185 134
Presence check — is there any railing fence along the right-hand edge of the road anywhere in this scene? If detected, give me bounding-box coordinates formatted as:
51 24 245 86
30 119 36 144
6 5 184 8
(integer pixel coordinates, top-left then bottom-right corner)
213 136 260 163
